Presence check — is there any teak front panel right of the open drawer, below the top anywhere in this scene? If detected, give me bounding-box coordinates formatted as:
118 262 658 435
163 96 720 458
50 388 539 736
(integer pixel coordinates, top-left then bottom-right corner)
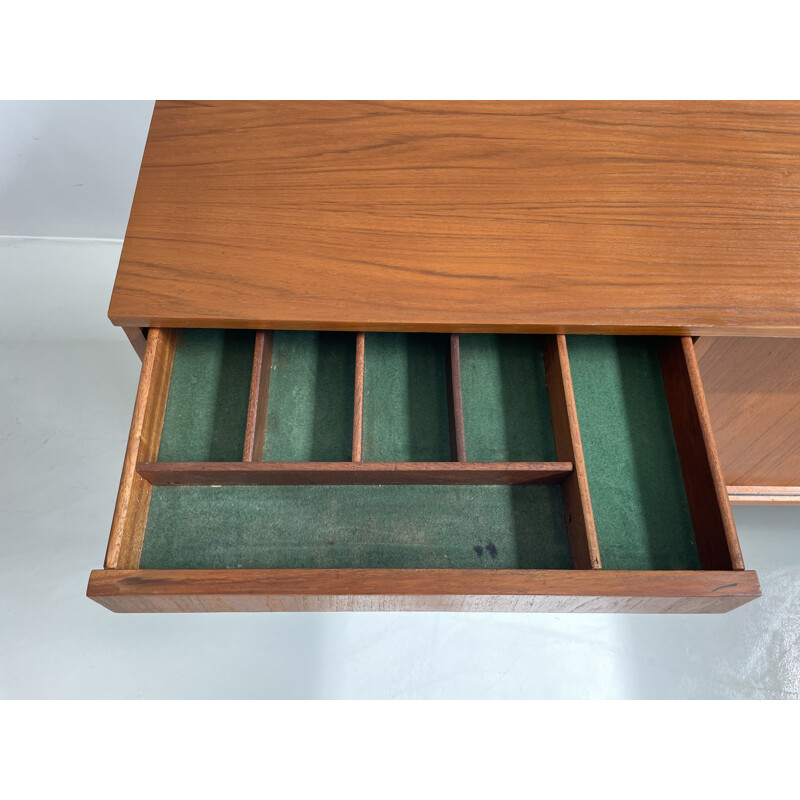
695 334 800 490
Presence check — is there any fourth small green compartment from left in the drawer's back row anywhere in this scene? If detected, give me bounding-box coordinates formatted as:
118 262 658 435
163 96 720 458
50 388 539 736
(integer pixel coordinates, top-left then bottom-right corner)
459 334 557 461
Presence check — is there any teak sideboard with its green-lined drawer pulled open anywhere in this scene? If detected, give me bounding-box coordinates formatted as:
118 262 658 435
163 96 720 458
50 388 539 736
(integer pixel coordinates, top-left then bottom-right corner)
88 101 800 613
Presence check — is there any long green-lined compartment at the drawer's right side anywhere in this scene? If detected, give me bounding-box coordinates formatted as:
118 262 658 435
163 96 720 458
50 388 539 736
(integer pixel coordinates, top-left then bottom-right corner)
566 336 700 570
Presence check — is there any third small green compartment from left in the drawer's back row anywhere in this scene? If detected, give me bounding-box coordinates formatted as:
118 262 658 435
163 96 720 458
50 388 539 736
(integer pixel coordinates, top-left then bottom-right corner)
363 333 450 462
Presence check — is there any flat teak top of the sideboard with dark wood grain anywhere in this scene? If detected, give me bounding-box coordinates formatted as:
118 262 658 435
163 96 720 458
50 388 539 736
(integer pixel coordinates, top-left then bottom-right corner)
109 101 800 336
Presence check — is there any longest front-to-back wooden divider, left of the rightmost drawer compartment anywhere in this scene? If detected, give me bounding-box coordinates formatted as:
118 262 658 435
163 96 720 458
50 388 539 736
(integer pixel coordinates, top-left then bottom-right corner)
543 334 601 569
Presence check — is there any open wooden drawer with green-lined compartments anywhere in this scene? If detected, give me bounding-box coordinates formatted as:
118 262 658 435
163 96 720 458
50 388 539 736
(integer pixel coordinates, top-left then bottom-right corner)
88 328 760 613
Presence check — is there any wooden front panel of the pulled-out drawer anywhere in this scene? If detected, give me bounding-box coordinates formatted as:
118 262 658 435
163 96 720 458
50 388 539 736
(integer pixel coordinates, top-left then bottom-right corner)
87 569 761 614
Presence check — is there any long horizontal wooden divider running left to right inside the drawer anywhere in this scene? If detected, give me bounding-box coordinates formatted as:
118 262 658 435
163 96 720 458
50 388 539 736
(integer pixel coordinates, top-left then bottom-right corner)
137 461 572 486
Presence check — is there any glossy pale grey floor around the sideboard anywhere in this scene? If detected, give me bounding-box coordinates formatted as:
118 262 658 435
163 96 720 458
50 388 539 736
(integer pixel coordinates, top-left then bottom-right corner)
0 238 800 698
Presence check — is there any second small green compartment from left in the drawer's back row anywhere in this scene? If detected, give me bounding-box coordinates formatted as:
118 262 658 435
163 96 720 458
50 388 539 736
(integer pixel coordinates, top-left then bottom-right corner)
263 331 355 462
